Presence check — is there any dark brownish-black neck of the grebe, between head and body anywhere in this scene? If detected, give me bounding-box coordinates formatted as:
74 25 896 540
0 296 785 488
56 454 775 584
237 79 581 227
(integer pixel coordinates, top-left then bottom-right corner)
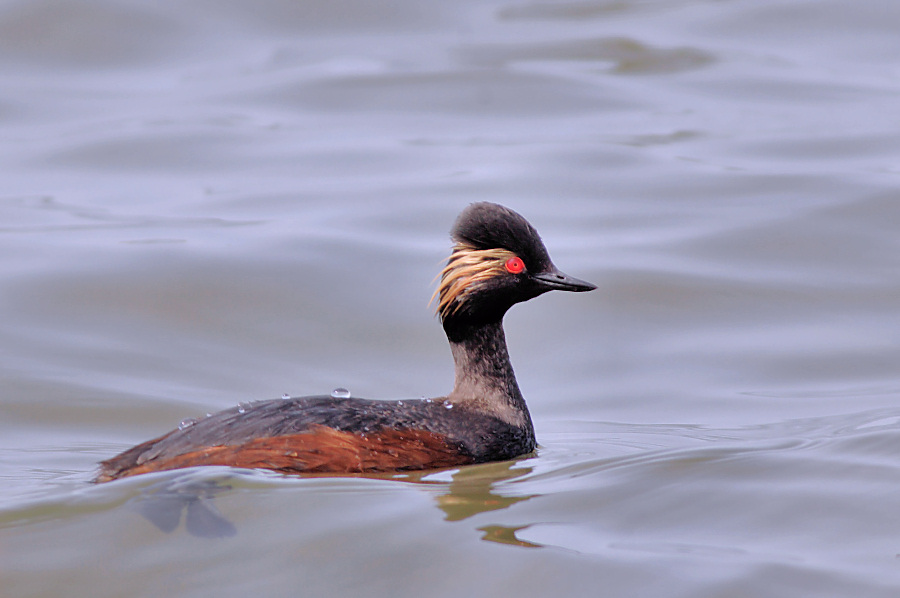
444 320 534 435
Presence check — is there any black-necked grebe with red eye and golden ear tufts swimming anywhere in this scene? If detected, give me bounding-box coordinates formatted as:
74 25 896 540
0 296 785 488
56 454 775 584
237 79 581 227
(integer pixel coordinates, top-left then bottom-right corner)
96 203 596 482
